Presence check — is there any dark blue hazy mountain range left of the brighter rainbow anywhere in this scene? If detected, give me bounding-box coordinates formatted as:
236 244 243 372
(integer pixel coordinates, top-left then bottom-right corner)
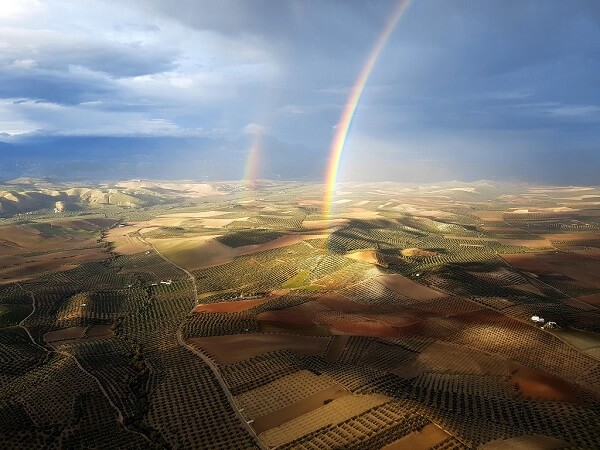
0 135 326 181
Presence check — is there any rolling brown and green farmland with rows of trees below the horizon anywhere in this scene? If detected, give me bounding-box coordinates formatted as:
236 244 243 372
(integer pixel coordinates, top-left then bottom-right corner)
0 178 600 449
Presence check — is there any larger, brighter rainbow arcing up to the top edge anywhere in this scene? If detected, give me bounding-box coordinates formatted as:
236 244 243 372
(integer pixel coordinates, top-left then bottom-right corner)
323 0 410 216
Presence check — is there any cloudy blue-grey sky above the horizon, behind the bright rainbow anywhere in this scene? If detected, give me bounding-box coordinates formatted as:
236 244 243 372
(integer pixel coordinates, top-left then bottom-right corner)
0 0 600 184
